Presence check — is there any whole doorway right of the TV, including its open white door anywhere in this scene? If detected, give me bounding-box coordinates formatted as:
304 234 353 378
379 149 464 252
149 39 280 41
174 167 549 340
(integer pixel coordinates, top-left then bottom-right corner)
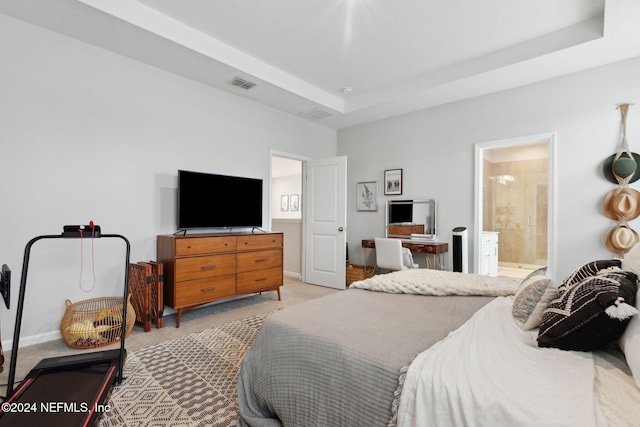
269 151 347 289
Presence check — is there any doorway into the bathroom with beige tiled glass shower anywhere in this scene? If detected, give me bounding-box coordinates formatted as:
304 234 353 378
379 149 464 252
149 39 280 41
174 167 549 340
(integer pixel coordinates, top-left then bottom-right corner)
476 134 554 278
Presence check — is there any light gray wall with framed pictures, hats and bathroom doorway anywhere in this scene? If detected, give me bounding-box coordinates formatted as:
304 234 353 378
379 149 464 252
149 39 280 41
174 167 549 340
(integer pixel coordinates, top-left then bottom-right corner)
338 58 640 280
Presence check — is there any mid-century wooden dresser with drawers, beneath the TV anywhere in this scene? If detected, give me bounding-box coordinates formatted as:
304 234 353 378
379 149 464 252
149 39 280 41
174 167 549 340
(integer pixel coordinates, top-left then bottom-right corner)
157 233 283 327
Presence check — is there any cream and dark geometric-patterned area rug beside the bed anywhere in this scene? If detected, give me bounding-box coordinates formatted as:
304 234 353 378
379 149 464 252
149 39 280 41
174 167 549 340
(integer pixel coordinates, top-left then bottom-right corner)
97 314 267 427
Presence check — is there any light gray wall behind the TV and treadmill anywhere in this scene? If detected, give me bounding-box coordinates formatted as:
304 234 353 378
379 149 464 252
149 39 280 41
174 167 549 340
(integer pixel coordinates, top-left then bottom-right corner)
0 14 336 343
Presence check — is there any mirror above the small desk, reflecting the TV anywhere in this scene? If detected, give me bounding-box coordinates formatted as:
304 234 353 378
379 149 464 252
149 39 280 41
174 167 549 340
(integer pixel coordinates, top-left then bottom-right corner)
385 199 437 240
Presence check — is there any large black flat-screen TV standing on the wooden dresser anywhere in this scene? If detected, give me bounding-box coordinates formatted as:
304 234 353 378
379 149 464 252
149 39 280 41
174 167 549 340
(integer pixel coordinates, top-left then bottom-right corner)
178 170 262 229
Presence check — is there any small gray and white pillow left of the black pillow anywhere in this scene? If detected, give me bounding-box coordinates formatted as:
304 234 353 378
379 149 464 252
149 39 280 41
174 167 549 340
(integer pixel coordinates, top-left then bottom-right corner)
511 267 558 331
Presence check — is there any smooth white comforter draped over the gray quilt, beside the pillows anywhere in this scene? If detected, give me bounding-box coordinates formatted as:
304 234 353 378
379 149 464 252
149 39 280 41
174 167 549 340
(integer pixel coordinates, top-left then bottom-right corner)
398 297 606 427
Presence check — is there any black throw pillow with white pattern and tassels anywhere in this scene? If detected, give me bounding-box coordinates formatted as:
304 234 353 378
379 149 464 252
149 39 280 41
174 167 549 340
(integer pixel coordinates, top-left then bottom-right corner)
538 270 637 351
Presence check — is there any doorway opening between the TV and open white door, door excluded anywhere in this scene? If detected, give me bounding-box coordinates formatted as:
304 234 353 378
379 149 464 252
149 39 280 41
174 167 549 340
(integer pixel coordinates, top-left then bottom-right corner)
271 155 303 279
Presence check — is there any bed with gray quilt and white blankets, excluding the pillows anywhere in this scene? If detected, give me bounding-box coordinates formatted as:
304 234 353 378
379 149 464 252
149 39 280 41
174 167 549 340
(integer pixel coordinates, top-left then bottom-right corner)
238 269 640 427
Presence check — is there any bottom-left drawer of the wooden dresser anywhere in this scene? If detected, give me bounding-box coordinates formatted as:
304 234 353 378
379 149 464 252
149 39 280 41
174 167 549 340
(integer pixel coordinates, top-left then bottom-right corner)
175 274 236 307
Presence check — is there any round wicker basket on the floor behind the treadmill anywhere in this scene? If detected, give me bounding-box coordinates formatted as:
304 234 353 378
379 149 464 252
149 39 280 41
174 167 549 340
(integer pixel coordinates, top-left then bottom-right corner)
60 296 136 349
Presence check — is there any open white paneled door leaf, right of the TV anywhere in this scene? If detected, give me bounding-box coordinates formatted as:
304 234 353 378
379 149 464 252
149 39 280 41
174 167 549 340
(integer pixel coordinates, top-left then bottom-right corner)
304 157 347 289
